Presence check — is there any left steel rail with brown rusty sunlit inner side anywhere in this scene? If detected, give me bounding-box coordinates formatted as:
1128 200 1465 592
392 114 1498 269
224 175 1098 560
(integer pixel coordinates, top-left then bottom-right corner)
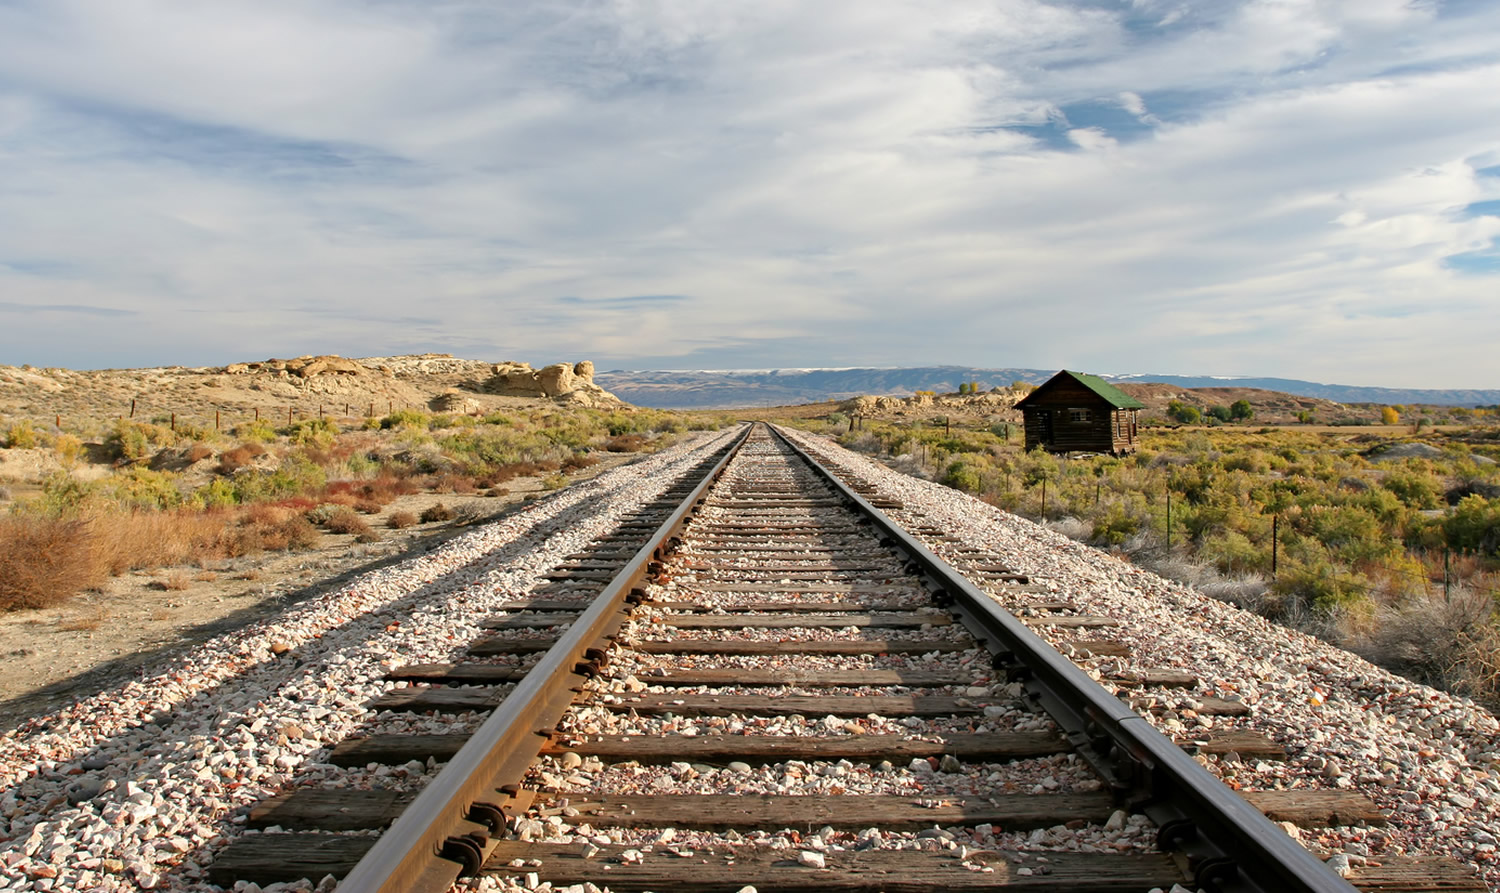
339 425 753 893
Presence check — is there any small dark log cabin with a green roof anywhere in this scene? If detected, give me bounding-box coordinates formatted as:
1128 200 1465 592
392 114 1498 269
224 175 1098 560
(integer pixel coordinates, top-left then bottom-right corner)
1016 369 1145 456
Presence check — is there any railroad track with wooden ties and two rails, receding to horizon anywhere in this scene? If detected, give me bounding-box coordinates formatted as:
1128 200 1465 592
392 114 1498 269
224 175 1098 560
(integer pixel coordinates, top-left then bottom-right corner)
212 426 1485 891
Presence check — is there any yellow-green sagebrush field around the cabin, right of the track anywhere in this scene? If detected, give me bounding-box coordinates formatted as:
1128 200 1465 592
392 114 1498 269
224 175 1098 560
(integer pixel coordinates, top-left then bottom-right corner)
828 414 1500 704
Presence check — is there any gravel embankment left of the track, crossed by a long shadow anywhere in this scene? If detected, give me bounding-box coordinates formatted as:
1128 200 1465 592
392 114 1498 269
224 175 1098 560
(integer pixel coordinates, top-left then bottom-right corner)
0 431 732 891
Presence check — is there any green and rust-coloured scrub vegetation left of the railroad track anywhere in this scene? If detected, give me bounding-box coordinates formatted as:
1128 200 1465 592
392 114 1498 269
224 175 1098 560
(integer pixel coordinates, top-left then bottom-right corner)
0 407 728 611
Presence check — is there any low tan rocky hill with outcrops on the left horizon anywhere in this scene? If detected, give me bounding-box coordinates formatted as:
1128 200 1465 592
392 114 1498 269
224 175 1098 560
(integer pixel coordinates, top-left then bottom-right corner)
0 354 623 423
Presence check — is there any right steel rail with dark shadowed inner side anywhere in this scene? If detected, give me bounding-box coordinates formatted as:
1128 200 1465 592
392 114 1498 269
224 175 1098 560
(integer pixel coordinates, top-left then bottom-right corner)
771 426 1355 893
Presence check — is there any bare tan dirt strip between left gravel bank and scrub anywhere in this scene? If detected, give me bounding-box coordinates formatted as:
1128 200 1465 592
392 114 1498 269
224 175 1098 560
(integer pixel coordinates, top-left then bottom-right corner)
0 453 638 732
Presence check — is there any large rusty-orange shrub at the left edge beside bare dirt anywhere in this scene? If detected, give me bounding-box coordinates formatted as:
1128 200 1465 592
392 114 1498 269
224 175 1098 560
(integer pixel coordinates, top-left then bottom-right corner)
0 515 105 611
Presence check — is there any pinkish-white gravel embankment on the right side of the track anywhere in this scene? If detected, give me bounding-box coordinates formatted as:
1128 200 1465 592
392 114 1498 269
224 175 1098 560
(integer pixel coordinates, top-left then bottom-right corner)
794 432 1500 890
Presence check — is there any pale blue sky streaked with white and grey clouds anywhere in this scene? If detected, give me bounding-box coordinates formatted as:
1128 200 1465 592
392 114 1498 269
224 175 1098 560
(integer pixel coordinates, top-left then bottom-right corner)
0 0 1500 387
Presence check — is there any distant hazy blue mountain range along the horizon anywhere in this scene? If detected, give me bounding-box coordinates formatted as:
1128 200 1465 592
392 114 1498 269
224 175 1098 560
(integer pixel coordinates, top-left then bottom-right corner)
594 366 1500 410
